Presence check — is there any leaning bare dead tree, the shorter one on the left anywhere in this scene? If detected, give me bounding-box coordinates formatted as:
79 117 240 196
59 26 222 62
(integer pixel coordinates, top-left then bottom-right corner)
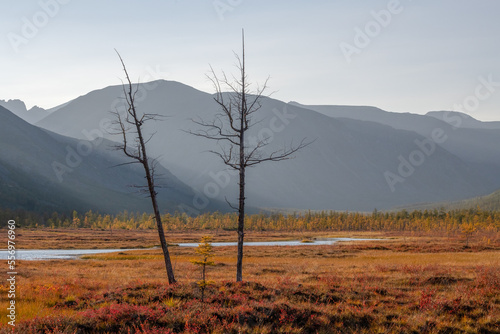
112 50 175 284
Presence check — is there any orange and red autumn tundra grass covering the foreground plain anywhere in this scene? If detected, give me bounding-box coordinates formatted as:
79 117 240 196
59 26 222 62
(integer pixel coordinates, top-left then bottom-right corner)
0 231 500 333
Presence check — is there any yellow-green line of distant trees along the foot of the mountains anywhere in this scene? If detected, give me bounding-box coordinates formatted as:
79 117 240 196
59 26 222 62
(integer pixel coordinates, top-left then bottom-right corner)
0 208 500 233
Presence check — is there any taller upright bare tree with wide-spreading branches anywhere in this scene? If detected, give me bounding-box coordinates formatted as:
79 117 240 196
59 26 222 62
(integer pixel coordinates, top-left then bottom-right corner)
190 31 309 282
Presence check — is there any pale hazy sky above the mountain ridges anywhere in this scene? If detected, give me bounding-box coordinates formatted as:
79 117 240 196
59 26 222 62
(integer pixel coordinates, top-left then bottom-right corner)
0 0 500 121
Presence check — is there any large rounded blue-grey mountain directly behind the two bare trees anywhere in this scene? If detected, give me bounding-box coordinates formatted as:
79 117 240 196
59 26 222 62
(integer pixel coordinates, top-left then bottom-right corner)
38 81 493 211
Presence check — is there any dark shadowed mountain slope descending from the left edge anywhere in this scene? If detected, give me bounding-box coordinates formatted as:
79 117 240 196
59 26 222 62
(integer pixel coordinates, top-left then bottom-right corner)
0 107 209 213
